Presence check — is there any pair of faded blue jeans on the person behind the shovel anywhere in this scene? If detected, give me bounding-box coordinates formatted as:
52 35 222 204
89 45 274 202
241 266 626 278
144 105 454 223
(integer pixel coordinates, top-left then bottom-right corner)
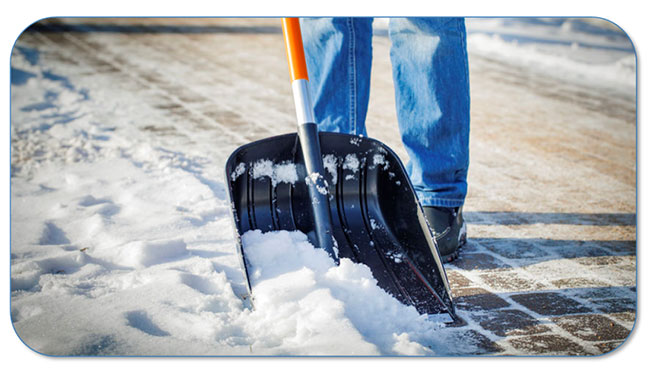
301 18 469 207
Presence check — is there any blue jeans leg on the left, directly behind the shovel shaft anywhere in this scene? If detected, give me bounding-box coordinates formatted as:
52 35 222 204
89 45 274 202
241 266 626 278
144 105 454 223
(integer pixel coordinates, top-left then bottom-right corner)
300 17 372 136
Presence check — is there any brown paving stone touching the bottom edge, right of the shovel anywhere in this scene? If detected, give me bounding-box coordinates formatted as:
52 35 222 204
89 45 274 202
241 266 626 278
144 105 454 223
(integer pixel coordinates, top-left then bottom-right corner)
508 334 591 356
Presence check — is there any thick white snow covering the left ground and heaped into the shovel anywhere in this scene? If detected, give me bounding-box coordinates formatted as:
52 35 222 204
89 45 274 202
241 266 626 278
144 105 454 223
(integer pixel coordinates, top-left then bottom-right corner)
11 53 454 355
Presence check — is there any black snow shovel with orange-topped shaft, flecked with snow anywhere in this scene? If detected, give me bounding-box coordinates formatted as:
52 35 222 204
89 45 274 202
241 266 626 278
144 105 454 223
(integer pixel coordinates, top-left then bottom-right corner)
226 18 458 321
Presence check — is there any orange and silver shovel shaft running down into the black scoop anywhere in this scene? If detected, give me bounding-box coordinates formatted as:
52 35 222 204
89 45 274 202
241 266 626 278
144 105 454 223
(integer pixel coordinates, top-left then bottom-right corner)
282 18 339 264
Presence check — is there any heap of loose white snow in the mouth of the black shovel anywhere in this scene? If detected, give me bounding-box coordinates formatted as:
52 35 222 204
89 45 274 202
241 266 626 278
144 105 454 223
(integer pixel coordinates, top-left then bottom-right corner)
242 231 447 355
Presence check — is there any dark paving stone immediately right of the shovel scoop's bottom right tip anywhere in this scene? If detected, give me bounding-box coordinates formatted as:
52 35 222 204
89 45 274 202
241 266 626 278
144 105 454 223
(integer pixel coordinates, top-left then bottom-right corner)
472 310 550 337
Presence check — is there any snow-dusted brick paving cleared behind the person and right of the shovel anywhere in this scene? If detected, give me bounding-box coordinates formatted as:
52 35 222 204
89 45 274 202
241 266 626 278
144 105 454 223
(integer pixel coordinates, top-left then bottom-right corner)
12 19 637 355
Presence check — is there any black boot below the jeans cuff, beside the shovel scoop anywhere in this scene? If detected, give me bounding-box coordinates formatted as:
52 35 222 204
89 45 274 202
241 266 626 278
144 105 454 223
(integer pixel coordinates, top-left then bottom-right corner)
423 206 467 263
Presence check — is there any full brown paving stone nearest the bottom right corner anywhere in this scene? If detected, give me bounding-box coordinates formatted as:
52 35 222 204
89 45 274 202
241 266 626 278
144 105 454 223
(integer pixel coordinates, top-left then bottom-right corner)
551 315 630 342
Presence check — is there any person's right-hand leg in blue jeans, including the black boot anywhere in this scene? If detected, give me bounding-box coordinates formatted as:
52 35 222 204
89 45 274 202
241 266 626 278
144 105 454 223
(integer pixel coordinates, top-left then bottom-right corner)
389 18 469 260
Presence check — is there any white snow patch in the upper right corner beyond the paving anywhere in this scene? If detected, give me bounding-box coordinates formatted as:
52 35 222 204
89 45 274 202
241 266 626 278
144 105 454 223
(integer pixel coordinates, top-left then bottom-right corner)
466 18 636 92
